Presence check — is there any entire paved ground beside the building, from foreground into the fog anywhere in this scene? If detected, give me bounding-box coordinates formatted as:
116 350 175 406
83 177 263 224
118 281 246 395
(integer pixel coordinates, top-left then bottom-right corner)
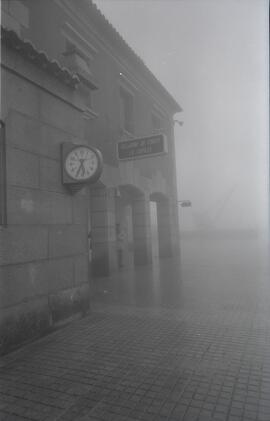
0 235 270 421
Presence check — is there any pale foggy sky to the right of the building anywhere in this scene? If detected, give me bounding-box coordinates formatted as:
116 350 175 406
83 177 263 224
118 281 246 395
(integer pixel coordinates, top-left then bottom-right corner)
95 0 269 240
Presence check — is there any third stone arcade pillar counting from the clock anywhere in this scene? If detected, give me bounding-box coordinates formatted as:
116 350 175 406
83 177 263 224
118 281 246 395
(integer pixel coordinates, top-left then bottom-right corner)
157 200 173 257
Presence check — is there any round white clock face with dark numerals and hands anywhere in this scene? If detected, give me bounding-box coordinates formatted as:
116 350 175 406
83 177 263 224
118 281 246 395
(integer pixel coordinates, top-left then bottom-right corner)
65 146 99 180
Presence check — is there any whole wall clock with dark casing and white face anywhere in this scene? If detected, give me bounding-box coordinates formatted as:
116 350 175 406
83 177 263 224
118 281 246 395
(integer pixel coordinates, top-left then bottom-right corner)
62 143 103 191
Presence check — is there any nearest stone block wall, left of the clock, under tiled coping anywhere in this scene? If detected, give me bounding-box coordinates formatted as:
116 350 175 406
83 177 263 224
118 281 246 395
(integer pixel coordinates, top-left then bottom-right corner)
0 52 89 352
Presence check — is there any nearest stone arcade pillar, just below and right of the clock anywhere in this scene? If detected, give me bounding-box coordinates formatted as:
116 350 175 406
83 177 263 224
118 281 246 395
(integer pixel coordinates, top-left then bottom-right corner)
90 187 117 276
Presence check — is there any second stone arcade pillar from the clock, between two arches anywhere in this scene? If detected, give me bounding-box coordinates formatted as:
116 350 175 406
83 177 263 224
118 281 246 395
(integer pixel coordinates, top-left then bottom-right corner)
132 195 152 266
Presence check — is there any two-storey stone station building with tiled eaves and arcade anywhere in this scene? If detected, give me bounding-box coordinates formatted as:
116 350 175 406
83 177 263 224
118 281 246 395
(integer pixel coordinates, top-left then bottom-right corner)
0 0 181 350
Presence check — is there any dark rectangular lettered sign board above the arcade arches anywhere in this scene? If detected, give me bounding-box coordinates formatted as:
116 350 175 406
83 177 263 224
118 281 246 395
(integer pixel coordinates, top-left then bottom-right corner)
117 134 168 161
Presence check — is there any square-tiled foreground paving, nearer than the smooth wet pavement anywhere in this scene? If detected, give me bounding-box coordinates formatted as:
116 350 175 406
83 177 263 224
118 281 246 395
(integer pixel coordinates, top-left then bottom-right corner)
0 254 270 421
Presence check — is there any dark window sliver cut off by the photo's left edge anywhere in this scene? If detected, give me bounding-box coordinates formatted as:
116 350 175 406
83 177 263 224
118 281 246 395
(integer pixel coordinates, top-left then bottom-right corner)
0 121 6 225
